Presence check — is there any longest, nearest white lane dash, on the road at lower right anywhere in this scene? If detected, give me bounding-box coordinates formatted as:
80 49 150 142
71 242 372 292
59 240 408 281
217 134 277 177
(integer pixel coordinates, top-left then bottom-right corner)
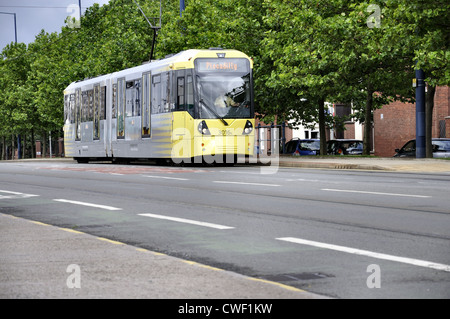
276 237 450 272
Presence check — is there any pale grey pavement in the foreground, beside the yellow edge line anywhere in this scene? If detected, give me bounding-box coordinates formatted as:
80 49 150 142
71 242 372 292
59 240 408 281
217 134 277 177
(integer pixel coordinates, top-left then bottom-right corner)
0 214 323 304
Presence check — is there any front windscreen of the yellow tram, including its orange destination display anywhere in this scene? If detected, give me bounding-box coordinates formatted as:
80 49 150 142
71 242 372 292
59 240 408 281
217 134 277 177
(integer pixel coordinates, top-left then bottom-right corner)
196 59 253 119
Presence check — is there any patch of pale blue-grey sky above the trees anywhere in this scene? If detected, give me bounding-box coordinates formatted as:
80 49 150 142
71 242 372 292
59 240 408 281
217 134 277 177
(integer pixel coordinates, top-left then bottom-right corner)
0 0 109 52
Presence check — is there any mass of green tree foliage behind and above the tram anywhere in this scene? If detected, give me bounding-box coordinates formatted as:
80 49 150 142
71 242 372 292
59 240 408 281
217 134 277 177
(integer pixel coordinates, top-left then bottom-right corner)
0 0 450 159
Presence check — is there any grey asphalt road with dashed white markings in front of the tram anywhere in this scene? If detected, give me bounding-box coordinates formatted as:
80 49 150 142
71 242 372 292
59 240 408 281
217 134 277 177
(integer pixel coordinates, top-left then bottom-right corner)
0 162 450 299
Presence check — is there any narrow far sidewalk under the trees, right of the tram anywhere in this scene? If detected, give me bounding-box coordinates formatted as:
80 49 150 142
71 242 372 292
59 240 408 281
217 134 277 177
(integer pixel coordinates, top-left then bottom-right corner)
279 155 450 174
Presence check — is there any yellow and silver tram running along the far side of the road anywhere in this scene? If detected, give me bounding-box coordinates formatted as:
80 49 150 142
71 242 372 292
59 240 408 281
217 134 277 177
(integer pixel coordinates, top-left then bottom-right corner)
64 48 255 163
